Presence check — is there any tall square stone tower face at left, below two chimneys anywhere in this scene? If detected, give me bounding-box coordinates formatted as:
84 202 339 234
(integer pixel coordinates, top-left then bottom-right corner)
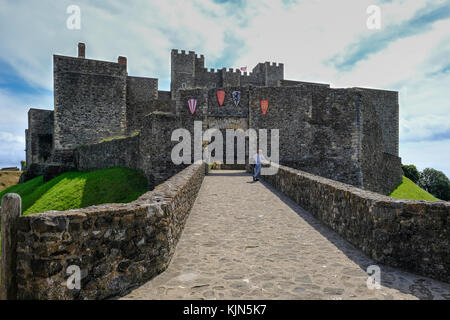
53 55 127 150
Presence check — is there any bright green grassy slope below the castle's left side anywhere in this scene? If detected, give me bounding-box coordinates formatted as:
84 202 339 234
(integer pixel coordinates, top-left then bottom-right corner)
0 168 147 214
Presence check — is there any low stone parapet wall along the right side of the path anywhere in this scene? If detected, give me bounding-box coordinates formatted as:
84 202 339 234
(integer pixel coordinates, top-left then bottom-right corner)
263 166 450 282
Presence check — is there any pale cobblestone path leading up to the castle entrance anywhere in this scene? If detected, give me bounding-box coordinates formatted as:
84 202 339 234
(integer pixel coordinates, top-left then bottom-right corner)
123 171 450 299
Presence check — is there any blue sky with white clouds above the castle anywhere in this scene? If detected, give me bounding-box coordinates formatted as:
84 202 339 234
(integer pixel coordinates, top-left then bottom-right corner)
0 0 450 177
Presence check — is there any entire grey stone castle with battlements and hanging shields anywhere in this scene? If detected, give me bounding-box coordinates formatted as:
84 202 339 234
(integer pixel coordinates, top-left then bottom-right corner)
22 43 402 194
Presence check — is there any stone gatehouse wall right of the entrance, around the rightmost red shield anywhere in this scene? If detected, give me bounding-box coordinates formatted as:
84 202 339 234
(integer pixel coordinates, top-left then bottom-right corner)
249 86 362 186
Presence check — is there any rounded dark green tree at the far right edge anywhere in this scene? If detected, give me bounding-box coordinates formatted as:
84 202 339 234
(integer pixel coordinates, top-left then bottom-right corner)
419 168 450 201
